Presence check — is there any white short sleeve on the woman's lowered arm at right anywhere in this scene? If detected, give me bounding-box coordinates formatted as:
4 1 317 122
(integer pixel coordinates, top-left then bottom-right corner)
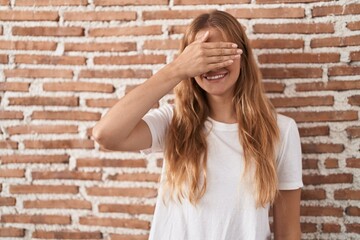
277 118 303 190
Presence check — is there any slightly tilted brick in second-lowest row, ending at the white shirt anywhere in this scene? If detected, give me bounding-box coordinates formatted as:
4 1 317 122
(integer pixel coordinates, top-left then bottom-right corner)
79 217 150 230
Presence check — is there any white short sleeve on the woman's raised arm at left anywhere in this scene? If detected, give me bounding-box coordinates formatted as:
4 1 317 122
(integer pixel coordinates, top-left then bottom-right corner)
142 104 173 154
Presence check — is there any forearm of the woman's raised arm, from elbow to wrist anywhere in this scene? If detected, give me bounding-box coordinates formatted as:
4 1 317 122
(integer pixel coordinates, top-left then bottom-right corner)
93 64 181 146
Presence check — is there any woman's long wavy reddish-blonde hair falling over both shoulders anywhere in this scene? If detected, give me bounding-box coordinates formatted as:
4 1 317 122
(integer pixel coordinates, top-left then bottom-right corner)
164 11 279 207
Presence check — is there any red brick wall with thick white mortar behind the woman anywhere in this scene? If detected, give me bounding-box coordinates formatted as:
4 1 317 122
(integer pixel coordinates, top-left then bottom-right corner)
0 0 360 240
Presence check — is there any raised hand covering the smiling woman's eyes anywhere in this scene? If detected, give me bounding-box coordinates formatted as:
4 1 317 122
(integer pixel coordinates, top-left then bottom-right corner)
172 31 242 79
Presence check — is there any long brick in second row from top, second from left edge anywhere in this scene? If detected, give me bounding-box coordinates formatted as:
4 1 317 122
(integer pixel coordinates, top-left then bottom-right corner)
64 11 136 21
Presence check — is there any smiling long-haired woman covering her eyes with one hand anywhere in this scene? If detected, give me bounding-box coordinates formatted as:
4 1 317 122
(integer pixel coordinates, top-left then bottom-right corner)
93 11 302 240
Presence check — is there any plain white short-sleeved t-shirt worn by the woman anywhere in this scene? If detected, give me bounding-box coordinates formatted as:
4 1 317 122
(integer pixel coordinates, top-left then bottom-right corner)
143 105 303 240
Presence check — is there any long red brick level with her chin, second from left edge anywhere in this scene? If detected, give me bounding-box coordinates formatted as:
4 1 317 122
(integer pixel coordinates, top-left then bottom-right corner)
43 82 115 93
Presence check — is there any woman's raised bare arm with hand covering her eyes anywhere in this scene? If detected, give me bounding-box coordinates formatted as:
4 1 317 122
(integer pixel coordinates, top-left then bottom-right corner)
93 33 240 151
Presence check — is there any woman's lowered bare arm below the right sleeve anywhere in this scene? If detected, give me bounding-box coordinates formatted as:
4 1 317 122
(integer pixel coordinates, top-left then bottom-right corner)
273 188 301 240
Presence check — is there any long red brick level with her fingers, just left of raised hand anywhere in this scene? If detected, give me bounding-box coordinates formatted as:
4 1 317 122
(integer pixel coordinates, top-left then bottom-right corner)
94 55 166 65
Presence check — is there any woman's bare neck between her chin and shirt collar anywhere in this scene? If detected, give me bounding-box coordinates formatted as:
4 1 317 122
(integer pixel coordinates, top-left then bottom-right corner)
208 96 237 123
